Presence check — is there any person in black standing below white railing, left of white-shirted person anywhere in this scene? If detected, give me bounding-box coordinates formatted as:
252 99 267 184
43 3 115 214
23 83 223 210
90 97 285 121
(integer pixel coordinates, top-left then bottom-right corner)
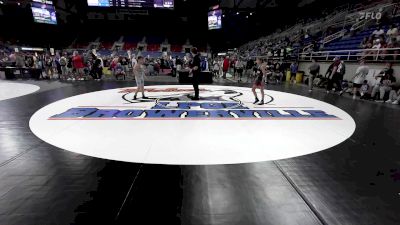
325 57 346 93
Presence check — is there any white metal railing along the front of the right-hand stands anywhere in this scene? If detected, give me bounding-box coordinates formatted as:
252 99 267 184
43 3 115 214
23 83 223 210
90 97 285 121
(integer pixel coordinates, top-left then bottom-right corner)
299 48 400 61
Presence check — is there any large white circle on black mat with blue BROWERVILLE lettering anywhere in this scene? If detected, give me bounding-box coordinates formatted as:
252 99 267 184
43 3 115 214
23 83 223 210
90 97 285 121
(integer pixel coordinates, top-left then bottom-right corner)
29 85 356 165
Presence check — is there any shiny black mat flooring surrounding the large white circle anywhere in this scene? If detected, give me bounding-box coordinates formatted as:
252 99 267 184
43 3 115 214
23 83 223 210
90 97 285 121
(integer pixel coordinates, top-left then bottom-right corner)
0 79 400 225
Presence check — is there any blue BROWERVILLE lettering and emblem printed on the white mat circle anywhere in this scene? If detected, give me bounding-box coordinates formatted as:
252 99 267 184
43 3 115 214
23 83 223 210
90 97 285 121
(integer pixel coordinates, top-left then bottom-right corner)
49 88 340 120
